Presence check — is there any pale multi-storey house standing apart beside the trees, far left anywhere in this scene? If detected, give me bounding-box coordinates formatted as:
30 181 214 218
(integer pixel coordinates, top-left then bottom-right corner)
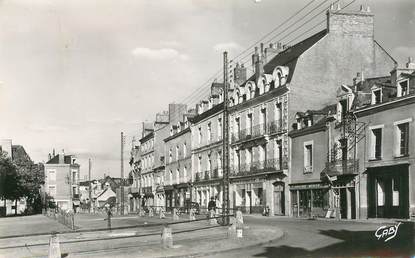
45 151 80 210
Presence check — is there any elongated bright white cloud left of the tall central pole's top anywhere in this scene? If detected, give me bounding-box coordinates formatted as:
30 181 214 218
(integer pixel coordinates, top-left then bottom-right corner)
132 47 189 60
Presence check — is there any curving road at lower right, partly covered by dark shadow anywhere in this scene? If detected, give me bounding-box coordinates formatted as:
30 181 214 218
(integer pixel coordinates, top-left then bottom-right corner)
209 216 415 257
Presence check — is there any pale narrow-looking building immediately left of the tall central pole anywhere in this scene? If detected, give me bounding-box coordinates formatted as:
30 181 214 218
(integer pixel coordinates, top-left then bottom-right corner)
190 82 223 208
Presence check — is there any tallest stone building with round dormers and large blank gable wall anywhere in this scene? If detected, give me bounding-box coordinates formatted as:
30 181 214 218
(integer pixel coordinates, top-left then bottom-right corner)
229 5 395 215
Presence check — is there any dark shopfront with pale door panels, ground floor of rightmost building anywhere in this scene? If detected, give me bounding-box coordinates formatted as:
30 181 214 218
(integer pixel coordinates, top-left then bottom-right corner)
367 165 409 218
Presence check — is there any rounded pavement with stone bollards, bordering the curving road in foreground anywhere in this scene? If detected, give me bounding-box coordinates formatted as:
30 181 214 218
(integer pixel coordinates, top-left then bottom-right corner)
68 223 283 257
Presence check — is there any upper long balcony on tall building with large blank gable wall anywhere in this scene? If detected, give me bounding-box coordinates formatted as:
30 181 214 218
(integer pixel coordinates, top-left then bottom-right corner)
231 120 285 143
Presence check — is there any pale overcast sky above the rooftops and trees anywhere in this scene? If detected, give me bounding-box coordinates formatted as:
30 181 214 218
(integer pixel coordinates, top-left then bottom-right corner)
0 0 415 178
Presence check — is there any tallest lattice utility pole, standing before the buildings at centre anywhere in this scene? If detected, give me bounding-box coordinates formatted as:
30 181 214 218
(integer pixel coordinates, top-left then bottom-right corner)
222 51 230 225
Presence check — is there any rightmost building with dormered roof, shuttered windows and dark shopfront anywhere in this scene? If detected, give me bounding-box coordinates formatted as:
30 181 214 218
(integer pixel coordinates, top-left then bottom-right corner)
354 59 415 218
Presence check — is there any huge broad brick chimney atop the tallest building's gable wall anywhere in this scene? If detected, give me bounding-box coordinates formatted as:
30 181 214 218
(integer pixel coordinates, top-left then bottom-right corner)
327 5 375 38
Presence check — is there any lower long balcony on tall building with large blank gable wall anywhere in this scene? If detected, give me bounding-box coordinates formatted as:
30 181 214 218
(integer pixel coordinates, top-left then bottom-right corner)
230 158 288 176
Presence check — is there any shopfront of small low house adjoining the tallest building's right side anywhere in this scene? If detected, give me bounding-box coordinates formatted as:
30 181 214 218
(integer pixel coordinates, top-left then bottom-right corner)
290 183 330 217
